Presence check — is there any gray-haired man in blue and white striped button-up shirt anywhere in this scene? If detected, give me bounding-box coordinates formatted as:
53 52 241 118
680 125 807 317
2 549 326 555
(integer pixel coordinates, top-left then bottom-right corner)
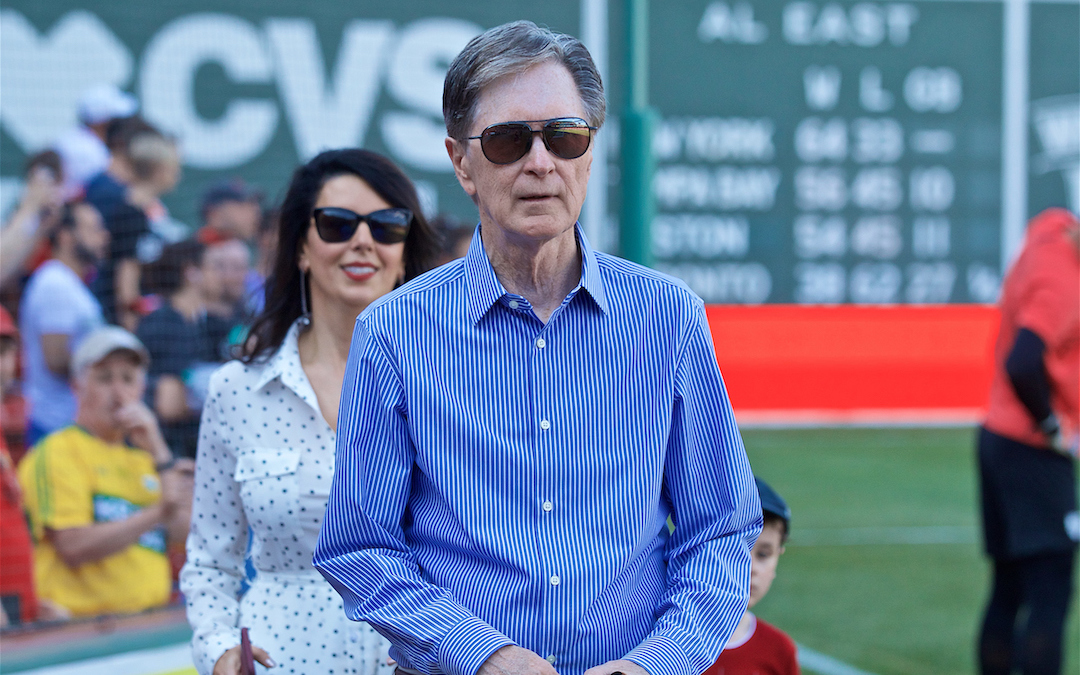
315 22 761 675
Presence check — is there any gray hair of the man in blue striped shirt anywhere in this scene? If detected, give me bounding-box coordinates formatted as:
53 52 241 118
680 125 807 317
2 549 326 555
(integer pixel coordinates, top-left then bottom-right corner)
443 21 607 140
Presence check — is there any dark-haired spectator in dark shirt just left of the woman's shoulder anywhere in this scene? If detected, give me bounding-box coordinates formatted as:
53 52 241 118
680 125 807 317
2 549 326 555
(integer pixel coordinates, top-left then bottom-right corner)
137 240 220 458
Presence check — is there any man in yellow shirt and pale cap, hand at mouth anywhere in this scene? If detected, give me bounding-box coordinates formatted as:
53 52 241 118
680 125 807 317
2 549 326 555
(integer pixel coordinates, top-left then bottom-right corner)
18 326 192 617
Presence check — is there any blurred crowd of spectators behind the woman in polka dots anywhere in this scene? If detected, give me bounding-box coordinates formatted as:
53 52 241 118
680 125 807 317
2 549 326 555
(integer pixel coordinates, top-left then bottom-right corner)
0 86 472 625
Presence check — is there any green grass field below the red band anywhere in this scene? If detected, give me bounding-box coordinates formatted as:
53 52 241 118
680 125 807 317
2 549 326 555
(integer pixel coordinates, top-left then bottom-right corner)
743 429 1080 675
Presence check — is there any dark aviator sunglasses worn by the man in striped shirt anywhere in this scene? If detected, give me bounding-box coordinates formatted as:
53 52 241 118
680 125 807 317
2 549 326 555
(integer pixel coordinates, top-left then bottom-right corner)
469 118 596 164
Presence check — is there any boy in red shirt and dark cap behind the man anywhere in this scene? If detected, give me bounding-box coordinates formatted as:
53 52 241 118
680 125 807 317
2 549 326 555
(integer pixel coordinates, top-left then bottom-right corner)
703 478 799 675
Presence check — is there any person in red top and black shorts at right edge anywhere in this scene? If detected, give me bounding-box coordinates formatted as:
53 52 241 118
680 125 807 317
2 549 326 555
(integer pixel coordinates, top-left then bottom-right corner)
978 208 1080 675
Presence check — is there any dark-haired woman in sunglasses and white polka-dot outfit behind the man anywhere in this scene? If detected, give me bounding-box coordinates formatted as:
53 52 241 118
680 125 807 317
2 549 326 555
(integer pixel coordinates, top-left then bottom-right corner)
180 149 438 675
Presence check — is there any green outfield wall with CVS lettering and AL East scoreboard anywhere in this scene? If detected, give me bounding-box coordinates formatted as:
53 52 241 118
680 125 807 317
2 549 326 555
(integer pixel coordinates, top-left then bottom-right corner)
0 0 1080 305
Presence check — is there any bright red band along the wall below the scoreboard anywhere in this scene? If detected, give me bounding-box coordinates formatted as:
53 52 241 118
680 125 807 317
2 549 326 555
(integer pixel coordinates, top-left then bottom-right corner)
706 305 998 423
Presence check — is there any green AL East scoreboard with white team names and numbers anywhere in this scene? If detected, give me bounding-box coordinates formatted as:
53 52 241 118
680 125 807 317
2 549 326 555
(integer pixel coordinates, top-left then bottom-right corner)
630 0 1080 305
